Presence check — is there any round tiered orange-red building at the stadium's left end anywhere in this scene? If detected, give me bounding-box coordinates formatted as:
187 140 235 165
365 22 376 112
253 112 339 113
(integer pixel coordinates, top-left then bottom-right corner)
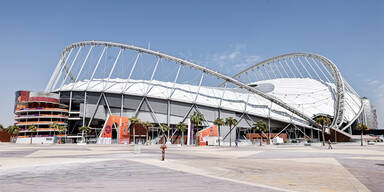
15 91 68 143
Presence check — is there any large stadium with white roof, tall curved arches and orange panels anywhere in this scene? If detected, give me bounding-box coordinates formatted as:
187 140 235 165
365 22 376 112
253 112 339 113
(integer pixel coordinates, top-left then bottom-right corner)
15 41 377 145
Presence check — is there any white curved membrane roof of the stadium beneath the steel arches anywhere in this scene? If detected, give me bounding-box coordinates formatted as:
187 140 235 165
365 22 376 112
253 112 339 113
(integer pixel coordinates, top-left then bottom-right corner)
57 78 360 125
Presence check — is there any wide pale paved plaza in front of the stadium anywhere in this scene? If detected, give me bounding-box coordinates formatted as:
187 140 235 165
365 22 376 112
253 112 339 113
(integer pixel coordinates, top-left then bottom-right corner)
0 143 384 192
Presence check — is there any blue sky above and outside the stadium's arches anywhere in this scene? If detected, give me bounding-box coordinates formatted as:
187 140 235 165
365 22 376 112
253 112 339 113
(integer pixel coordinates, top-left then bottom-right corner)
0 0 384 127
